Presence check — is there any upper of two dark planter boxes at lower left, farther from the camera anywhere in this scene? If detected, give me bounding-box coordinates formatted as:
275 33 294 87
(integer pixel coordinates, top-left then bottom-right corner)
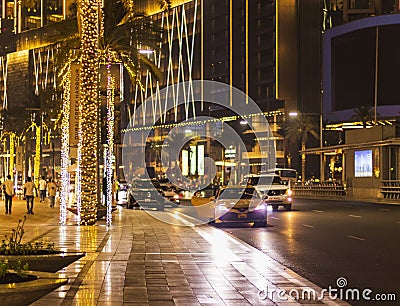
0 252 86 273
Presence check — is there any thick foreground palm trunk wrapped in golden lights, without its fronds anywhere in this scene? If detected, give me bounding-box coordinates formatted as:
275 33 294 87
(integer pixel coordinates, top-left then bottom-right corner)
78 0 101 225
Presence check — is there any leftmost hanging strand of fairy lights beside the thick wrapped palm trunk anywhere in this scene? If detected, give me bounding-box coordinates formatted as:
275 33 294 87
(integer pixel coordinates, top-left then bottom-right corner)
60 66 71 225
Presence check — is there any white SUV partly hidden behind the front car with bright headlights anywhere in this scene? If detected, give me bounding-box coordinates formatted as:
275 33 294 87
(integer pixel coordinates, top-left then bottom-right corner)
241 173 293 211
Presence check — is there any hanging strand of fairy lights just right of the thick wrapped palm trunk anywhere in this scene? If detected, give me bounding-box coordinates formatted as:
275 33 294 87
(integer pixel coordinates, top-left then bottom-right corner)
105 61 115 226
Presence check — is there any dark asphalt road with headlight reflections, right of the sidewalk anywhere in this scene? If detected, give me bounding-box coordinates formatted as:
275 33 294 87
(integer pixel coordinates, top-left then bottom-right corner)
220 199 400 305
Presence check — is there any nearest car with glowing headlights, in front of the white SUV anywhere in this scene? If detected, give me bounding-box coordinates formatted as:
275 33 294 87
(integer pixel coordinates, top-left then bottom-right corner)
214 186 267 227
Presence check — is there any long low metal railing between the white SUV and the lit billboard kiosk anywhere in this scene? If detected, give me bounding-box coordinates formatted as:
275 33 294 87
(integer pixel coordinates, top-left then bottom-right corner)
292 182 346 197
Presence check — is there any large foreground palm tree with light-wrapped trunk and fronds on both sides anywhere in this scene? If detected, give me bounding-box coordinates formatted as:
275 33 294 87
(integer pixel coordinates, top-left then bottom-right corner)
41 0 170 224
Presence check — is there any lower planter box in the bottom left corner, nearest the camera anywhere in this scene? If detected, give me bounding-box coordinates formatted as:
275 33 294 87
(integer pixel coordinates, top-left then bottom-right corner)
0 271 68 305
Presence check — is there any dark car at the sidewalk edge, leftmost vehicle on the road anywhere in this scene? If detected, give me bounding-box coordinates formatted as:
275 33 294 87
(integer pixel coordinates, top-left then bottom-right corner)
126 179 165 211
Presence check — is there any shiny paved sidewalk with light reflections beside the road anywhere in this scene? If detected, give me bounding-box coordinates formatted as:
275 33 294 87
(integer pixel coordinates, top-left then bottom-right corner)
0 199 348 306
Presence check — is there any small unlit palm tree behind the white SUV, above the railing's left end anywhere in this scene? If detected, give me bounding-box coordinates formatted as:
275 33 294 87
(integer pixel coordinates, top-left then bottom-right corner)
284 114 319 182
